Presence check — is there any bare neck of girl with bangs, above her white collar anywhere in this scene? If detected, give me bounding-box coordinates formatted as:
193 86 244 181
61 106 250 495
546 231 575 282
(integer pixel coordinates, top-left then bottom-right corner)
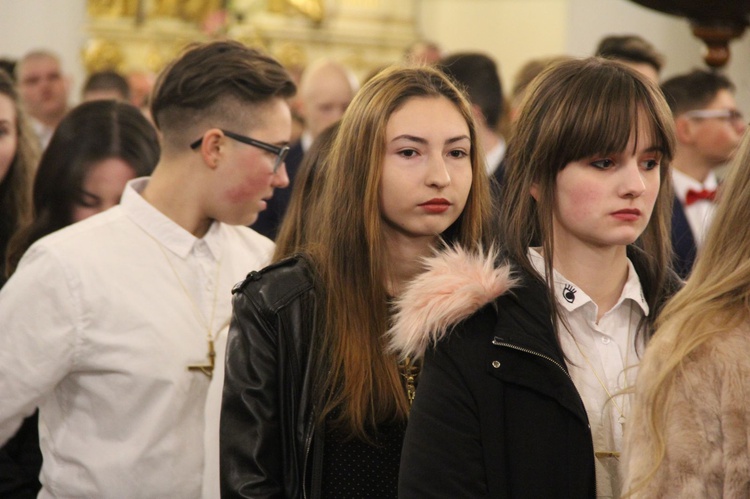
552 241 628 321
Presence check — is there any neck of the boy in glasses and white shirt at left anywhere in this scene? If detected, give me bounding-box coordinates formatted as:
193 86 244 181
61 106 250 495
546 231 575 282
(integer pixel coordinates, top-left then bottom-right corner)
142 163 212 238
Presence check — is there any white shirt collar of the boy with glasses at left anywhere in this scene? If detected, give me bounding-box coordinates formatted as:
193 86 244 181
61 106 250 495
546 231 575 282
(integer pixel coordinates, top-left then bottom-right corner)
120 177 222 259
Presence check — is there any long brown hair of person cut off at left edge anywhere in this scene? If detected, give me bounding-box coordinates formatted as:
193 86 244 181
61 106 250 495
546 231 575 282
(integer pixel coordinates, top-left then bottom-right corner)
0 70 39 283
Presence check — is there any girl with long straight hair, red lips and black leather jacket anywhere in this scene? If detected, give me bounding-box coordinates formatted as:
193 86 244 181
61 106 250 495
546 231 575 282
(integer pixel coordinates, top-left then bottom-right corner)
221 67 491 498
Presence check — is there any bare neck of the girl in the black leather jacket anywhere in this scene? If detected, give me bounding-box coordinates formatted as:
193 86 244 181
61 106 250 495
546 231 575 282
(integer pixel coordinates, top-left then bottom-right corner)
385 231 437 296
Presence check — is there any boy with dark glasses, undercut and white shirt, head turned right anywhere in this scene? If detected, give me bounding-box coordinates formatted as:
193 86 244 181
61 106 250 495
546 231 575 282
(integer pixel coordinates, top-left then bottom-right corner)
0 42 295 498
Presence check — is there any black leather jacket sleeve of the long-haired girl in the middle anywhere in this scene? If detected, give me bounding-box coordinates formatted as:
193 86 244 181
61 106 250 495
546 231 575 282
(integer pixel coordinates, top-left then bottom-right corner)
220 292 284 499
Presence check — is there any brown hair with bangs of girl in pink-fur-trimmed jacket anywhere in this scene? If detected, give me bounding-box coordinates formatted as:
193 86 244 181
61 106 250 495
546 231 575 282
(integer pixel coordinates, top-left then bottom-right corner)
500 58 675 344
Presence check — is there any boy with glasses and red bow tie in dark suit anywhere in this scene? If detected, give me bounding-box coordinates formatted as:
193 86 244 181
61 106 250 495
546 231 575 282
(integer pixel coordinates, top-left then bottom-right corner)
661 69 746 278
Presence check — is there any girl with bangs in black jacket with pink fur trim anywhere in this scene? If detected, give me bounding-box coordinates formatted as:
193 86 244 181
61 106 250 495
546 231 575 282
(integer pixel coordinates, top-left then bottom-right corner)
390 58 679 499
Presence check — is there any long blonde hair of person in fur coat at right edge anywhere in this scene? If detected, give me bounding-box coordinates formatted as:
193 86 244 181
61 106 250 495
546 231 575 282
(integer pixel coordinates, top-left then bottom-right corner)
630 129 750 494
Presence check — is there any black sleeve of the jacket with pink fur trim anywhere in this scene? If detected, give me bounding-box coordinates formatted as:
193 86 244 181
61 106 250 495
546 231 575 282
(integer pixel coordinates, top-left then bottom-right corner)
398 316 488 499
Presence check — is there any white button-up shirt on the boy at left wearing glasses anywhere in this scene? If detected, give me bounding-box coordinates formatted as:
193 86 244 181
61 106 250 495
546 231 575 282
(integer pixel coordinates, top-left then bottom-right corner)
0 179 273 498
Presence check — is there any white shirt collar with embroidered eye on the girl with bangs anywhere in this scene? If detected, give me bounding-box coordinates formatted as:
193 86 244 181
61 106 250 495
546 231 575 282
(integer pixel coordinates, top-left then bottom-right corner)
529 248 649 315
